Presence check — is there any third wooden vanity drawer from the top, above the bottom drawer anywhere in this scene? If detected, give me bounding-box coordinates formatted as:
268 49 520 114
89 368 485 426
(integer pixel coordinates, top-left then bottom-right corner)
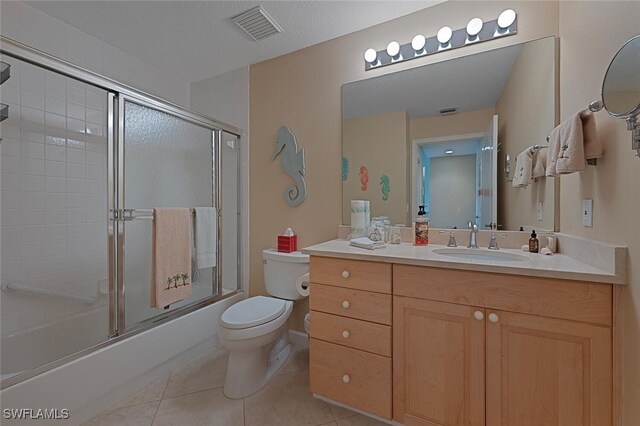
310 311 391 357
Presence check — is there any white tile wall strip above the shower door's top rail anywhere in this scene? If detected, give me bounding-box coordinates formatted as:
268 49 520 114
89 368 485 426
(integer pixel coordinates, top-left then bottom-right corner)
0 1 189 107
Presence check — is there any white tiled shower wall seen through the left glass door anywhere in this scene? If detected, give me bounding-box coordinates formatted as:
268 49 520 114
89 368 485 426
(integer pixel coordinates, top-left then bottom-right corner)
0 55 107 335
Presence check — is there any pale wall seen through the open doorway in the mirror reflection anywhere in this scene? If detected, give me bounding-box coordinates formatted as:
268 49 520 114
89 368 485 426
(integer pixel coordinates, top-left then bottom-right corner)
429 155 477 228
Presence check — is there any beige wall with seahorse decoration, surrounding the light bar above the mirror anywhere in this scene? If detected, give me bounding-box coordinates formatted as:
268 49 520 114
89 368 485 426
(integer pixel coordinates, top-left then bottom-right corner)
249 1 558 329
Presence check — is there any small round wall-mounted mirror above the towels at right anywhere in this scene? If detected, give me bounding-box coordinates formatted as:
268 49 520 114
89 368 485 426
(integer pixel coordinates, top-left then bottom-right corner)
602 35 640 118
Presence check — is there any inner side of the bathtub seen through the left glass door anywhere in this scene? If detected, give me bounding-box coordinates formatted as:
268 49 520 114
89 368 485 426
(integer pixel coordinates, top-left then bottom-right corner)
0 305 109 380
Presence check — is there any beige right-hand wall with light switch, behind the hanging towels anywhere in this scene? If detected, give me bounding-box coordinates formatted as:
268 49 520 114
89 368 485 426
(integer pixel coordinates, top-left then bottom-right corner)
560 2 640 426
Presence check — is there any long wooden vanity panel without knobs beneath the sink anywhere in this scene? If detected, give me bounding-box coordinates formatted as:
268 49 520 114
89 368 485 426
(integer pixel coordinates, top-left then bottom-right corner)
393 265 613 325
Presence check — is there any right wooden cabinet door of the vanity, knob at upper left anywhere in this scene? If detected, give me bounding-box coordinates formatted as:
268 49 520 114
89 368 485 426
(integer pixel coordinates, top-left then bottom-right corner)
486 309 612 426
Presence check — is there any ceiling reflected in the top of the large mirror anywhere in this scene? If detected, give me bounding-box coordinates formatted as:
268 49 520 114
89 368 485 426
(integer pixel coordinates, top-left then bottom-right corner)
342 45 522 119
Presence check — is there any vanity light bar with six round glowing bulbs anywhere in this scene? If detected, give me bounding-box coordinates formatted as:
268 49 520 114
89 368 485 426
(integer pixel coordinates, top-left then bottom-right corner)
364 9 518 71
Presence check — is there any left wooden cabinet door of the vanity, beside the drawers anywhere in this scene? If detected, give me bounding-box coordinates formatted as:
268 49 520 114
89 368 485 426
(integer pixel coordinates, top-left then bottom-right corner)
393 296 485 426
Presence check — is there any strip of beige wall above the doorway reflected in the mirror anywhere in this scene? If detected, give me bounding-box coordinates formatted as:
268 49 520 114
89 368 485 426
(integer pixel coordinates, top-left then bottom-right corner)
410 108 495 141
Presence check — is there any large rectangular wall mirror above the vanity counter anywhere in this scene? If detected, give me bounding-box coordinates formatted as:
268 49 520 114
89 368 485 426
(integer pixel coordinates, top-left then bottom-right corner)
342 37 557 231
